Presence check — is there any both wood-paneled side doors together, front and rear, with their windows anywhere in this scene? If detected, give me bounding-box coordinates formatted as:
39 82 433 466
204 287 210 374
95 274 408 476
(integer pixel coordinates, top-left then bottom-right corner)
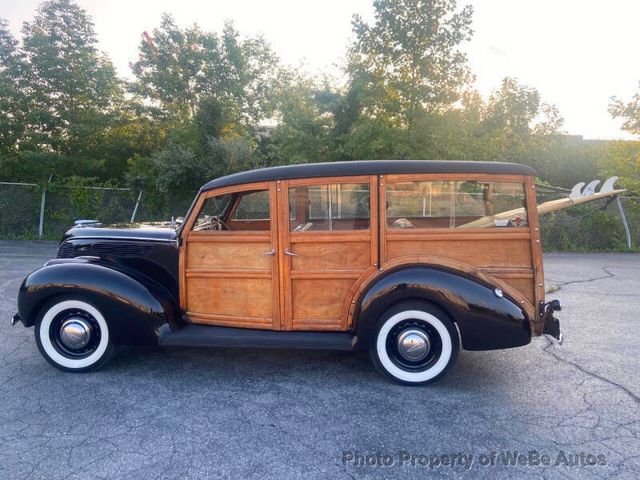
180 175 378 331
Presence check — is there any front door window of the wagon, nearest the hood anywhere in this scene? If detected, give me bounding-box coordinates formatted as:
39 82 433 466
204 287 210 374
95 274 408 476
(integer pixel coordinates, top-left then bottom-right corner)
193 190 271 232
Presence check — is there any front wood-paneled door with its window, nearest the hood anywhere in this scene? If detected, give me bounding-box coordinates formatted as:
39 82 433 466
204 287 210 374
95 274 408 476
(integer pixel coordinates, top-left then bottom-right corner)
180 182 280 330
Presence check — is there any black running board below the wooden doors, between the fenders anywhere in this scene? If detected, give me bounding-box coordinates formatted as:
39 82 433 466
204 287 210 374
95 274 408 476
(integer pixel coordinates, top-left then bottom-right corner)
158 324 357 350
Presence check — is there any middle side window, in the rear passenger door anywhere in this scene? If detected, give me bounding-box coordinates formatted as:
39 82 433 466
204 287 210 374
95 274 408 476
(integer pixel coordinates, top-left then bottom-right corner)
289 183 370 232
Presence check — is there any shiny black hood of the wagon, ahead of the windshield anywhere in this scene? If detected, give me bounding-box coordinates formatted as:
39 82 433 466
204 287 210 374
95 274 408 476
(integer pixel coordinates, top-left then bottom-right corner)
62 222 177 242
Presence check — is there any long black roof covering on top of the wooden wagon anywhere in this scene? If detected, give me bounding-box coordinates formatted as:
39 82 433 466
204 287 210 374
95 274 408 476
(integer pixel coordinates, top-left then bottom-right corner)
200 160 536 191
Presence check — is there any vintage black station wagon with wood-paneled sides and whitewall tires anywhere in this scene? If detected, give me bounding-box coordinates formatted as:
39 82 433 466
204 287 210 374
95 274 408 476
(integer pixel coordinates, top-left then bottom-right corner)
13 161 561 384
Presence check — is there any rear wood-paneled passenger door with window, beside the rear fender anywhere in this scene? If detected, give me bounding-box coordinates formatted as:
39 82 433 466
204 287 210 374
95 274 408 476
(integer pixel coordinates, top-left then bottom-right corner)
278 176 378 331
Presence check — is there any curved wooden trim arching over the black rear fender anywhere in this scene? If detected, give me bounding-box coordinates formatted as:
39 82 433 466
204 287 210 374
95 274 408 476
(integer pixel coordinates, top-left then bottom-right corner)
342 255 535 327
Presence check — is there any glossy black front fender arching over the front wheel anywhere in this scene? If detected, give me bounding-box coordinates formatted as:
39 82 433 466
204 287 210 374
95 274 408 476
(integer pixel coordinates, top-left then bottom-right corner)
18 259 182 345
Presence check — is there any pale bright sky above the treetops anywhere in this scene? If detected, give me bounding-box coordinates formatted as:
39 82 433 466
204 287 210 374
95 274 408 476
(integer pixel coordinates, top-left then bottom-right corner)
0 0 640 138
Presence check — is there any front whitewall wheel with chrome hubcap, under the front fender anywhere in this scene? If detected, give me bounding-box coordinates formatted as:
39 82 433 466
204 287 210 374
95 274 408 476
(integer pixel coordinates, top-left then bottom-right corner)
35 297 115 372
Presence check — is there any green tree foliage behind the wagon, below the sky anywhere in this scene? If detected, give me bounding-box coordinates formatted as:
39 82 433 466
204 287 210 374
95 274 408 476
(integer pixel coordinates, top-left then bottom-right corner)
0 0 640 198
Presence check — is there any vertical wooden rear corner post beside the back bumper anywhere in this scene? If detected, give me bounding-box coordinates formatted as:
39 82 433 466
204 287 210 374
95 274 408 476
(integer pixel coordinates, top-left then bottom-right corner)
525 177 545 335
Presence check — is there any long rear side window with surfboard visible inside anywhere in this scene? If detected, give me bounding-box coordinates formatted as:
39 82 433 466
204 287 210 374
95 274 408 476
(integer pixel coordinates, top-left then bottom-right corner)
387 180 528 229
